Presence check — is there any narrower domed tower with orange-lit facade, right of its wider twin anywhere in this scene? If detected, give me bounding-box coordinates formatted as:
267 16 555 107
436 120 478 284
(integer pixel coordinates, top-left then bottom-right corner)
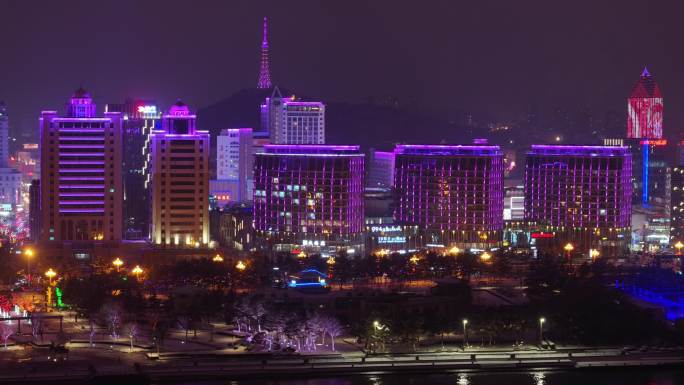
149 100 209 247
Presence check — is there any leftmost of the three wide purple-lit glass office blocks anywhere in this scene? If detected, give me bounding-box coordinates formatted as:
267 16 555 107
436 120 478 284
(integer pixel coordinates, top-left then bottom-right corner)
254 145 364 255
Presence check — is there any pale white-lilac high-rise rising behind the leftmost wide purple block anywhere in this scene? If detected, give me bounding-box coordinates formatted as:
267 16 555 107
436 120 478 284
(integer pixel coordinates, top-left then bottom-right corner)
271 99 325 144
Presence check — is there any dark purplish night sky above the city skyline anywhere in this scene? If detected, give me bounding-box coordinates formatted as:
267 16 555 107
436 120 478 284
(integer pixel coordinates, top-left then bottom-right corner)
0 0 684 135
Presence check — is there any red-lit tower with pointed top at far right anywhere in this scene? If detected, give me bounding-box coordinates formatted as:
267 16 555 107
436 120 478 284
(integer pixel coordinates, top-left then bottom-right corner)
627 68 663 139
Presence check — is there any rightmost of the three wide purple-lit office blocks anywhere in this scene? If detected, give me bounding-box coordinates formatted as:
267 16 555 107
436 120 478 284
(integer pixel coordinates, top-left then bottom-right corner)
525 145 632 256
